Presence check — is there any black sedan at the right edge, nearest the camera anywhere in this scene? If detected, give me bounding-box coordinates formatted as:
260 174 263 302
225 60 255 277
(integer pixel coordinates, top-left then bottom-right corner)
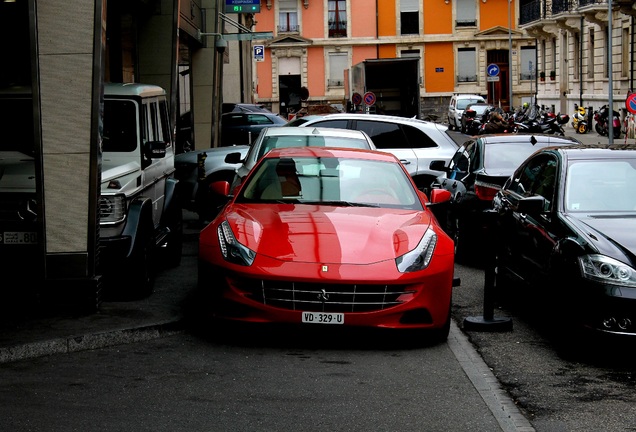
493 143 636 342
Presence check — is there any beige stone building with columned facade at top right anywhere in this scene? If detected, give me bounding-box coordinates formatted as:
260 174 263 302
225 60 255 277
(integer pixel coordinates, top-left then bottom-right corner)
519 0 636 118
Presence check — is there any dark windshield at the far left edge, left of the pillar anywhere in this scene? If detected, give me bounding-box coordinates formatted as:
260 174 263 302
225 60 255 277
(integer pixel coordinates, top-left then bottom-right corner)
0 97 35 156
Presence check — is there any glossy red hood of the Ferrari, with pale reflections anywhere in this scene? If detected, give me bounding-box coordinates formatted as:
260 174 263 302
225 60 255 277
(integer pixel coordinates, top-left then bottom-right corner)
226 204 431 264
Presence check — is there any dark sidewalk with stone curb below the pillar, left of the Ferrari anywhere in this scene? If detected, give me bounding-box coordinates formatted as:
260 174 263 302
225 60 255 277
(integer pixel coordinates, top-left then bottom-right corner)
0 212 199 364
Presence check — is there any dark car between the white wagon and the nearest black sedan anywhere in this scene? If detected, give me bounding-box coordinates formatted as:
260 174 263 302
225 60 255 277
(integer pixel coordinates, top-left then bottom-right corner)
431 134 579 261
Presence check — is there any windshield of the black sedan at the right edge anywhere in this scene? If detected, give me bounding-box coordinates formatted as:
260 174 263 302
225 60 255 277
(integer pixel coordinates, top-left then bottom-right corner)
565 159 636 212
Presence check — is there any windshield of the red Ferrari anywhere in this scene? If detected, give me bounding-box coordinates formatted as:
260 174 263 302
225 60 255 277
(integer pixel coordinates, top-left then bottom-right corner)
237 157 423 210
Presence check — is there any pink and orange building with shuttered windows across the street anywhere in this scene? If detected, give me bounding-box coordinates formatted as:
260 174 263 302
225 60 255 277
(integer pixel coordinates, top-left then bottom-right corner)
252 0 536 120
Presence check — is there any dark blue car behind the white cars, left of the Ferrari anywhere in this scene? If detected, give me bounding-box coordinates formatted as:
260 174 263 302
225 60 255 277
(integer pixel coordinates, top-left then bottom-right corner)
221 112 287 146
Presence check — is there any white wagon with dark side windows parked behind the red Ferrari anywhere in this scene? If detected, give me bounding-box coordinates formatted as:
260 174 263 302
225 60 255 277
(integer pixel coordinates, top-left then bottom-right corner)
287 113 458 192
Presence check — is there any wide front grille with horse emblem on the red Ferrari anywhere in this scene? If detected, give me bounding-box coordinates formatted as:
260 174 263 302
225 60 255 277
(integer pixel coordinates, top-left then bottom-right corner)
234 279 414 312
